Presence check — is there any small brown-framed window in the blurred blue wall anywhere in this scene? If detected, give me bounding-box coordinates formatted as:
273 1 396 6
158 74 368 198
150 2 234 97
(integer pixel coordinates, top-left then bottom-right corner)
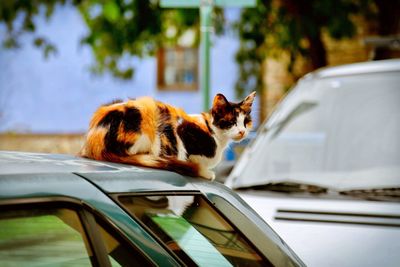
157 47 198 91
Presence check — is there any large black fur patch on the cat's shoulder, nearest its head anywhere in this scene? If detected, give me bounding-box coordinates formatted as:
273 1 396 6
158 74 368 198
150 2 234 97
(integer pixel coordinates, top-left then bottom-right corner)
177 121 217 158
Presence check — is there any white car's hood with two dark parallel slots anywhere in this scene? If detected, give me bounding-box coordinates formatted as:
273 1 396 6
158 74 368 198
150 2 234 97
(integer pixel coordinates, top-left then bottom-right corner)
239 192 400 267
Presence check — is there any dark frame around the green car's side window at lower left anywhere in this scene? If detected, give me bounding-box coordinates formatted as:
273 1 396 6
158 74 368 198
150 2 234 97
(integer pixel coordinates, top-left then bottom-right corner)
0 197 157 267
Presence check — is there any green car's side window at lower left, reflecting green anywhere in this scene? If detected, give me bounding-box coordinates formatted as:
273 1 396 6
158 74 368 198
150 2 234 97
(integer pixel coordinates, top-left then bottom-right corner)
0 204 153 267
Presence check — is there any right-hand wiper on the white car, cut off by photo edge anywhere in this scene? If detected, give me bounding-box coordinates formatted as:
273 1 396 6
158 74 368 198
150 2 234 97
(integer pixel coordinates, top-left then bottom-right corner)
339 187 400 202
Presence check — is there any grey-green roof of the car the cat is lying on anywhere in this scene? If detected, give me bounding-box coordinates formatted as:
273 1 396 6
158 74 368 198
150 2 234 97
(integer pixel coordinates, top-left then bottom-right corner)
0 151 302 265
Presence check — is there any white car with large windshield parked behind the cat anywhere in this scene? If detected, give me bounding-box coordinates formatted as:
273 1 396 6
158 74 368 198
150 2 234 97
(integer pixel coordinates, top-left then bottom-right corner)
226 60 400 267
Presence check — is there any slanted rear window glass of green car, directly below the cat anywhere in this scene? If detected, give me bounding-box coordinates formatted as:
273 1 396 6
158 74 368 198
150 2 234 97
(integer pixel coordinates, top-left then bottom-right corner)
119 195 269 266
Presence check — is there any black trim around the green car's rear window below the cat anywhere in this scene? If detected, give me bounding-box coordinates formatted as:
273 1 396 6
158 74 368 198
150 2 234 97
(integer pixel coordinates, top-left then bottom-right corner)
109 190 272 266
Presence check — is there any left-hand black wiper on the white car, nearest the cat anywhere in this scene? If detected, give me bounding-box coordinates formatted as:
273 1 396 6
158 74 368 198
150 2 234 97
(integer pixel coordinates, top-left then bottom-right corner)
236 182 328 194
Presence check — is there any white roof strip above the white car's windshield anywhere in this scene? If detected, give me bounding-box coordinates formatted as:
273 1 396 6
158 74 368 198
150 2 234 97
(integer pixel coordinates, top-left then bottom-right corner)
304 59 400 79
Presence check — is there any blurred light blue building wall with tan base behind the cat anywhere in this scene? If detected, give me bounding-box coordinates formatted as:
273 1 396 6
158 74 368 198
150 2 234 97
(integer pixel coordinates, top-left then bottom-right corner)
0 5 247 154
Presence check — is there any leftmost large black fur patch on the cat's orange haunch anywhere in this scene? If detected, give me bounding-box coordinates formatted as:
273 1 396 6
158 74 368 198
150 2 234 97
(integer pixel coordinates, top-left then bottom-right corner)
99 110 132 156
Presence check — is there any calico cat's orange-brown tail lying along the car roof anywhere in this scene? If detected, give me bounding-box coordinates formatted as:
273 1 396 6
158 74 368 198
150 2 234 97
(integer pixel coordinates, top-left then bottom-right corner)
102 153 199 177
